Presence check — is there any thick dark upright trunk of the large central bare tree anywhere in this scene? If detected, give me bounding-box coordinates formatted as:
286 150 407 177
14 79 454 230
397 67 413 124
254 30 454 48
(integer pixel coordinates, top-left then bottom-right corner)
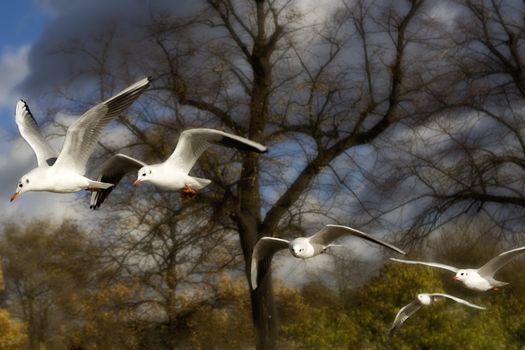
239 0 277 344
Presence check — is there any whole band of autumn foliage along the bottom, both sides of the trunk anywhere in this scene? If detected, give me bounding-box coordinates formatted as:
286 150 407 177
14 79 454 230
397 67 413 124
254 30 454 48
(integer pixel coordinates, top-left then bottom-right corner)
5 222 525 350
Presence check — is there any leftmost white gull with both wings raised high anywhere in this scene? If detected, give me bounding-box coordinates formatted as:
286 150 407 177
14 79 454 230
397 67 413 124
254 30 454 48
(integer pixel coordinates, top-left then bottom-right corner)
11 78 150 202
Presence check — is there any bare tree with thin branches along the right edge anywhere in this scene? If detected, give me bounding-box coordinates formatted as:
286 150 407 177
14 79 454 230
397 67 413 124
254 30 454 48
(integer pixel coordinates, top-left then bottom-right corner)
372 0 525 240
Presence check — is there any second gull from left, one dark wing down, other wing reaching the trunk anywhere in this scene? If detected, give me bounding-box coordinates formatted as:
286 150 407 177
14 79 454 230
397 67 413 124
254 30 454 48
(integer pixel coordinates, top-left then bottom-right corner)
90 128 267 209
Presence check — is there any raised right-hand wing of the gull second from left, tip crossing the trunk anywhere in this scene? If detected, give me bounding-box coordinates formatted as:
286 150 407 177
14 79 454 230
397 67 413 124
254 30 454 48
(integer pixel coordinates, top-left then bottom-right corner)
166 128 266 173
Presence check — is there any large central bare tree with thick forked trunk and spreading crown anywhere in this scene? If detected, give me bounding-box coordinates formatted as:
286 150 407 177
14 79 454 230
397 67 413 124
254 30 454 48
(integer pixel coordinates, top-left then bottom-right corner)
136 1 434 349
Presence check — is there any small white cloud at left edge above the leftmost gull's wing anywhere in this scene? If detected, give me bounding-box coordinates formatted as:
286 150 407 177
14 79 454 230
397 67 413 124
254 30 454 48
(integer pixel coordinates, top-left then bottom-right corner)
0 45 30 108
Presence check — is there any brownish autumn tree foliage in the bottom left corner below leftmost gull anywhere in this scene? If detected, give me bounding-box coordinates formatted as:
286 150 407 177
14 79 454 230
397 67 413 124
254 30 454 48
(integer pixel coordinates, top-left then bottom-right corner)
0 221 140 349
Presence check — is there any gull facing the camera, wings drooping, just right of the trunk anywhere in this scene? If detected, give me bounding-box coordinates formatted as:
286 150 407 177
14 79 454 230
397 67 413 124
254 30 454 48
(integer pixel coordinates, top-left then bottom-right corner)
251 225 405 290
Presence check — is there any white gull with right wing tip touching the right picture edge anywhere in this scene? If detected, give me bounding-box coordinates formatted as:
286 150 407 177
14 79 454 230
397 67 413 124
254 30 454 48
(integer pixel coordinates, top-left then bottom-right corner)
390 246 525 292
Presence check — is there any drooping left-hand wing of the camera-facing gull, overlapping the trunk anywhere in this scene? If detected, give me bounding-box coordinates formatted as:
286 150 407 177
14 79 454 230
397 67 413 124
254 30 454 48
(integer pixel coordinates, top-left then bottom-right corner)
250 237 290 290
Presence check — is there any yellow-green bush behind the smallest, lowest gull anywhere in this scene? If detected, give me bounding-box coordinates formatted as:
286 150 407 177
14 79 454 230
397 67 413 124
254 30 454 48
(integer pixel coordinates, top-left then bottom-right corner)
349 264 525 349
